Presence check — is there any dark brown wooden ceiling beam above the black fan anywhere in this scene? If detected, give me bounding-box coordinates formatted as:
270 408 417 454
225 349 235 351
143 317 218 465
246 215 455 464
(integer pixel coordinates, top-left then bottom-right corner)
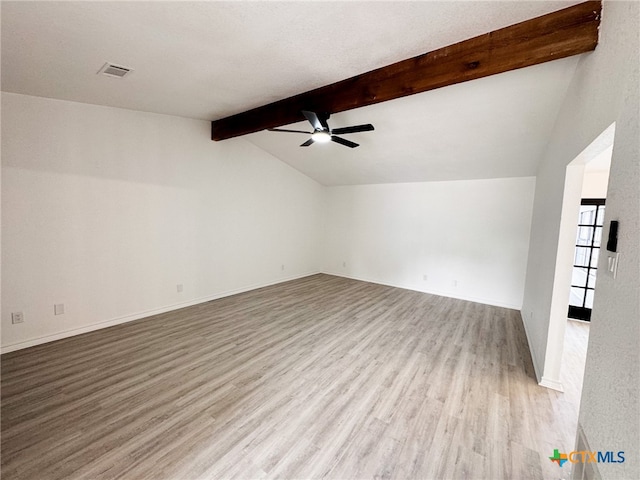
211 1 602 140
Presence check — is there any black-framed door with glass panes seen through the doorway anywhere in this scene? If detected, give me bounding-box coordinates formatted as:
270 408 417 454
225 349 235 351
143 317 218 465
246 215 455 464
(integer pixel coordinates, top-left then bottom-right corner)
569 198 605 321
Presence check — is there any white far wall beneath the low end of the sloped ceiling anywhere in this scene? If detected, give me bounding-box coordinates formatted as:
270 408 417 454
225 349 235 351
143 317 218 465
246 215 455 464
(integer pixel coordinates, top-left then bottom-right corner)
324 177 535 308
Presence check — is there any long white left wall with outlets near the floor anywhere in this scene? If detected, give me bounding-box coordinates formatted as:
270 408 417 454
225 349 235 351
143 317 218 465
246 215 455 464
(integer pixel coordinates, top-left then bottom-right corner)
2 93 324 351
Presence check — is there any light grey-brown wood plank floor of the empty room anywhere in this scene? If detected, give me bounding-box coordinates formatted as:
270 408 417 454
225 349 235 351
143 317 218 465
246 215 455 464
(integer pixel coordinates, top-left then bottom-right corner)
2 275 577 480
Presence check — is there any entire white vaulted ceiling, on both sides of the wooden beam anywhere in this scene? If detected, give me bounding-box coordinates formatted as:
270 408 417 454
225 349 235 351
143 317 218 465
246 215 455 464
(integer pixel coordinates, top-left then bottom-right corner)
2 1 579 185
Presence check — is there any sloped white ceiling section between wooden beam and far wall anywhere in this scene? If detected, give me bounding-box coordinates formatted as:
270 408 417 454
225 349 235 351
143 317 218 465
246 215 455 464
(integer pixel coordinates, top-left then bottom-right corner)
245 58 576 185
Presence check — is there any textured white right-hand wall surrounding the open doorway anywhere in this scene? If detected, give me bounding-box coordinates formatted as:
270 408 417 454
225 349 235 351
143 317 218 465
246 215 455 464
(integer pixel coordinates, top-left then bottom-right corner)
523 2 640 479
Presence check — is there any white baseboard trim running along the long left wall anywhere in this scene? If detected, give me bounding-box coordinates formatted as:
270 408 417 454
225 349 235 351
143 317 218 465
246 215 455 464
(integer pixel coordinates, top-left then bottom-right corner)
0 271 321 354
